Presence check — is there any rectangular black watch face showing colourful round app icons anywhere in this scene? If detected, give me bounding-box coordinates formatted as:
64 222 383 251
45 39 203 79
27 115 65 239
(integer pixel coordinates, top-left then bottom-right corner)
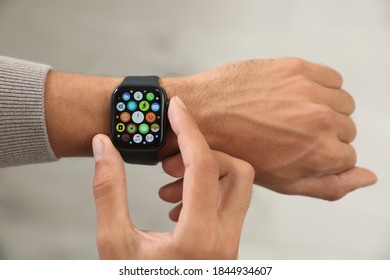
111 86 166 150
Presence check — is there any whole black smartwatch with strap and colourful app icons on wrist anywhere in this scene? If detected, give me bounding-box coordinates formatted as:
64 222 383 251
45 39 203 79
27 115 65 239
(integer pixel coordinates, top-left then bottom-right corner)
110 76 168 165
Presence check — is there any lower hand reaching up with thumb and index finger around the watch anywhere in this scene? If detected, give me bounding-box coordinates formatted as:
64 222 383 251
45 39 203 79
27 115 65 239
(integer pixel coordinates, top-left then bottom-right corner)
93 98 254 259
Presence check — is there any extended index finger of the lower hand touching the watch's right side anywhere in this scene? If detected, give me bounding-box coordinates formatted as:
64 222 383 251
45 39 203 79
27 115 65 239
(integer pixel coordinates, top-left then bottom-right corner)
168 96 219 219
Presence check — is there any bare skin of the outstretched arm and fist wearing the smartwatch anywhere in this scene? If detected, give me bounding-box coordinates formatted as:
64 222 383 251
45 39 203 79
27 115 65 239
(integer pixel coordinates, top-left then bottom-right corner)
45 58 377 200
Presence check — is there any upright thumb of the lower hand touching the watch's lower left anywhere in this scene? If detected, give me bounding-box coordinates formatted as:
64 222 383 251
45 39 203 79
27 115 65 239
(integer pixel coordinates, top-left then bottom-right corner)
92 134 131 230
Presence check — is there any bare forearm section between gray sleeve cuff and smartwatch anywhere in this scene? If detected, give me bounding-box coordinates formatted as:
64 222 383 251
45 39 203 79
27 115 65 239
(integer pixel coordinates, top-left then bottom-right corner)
45 71 122 157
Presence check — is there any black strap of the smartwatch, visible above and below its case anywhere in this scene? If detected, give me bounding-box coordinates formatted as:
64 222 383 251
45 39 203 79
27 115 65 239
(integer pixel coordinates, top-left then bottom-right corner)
119 76 160 165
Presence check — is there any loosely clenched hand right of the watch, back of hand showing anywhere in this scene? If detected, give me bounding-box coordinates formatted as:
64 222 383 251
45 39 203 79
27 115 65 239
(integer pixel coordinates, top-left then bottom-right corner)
160 58 376 200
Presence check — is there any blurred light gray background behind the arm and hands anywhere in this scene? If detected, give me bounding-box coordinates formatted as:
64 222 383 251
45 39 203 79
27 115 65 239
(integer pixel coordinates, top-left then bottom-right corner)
0 0 390 259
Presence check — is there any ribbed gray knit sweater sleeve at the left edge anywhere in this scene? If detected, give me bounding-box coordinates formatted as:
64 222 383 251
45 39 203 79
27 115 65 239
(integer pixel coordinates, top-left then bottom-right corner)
0 56 57 167
